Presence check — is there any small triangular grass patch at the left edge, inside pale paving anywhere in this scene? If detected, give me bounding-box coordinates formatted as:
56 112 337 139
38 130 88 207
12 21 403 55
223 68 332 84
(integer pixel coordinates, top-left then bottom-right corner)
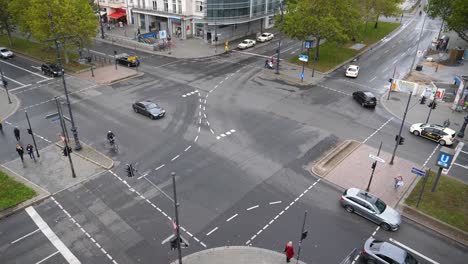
0 171 36 211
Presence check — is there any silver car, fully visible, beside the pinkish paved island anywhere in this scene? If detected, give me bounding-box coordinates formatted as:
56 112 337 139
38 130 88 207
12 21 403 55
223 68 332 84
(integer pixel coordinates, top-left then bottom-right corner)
340 188 401 231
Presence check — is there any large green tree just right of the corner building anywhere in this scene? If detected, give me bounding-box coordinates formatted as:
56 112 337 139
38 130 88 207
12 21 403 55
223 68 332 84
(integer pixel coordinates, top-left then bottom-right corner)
276 0 362 59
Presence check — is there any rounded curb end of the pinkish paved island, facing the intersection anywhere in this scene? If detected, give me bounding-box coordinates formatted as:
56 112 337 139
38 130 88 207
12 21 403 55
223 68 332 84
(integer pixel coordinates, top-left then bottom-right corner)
311 139 362 178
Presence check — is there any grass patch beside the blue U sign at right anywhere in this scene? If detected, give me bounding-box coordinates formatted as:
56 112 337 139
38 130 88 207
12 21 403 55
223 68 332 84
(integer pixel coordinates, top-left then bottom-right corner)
406 171 468 232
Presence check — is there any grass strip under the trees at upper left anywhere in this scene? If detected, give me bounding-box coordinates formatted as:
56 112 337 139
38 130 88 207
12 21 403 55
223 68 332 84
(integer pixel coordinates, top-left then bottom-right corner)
0 35 89 72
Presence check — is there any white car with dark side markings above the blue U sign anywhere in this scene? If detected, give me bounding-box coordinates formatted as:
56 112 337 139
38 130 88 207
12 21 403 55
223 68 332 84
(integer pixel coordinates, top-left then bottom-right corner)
410 123 456 146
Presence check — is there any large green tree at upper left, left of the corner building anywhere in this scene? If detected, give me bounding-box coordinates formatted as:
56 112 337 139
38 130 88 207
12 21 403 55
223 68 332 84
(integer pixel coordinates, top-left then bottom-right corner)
9 0 98 63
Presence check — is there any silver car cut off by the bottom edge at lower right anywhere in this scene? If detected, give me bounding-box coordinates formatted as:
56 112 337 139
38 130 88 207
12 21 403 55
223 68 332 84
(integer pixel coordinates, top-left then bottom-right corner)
361 237 419 264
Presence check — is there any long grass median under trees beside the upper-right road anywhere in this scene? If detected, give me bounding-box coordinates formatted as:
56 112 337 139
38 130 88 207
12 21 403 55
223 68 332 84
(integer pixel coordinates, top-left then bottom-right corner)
289 22 400 72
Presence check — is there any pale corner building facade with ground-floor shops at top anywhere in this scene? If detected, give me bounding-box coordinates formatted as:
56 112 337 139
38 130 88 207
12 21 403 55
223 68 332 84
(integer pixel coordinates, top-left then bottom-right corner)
122 0 279 43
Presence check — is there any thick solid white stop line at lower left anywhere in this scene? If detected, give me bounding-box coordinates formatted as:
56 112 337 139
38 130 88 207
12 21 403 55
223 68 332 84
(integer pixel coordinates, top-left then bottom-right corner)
25 206 81 264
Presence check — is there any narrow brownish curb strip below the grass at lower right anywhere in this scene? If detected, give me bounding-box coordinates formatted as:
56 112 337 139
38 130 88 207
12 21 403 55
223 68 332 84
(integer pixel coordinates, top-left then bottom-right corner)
402 204 468 247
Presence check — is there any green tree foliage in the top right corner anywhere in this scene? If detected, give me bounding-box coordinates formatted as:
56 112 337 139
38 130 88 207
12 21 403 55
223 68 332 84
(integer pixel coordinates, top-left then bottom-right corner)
425 0 468 41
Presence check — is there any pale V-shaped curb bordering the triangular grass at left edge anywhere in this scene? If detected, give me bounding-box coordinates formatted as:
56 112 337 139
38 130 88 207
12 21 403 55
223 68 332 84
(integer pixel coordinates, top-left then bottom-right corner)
0 165 51 219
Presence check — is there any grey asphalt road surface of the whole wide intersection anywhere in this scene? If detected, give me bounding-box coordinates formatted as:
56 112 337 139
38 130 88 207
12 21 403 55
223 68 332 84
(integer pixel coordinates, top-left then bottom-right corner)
0 9 468 263
